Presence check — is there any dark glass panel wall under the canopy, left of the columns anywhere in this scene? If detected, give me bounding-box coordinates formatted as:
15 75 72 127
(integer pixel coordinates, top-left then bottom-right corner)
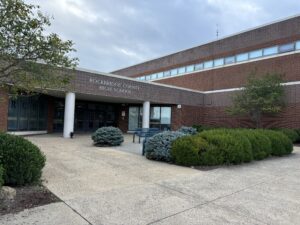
7 95 47 131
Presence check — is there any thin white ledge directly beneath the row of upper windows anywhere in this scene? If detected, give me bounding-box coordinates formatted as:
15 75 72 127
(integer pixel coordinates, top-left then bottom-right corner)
150 50 300 82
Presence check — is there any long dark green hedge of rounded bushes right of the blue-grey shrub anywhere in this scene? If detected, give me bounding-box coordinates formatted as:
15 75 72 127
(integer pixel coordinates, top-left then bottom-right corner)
171 129 293 166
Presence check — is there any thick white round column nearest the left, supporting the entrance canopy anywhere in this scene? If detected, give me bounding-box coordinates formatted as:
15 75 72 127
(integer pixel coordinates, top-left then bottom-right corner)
64 92 75 138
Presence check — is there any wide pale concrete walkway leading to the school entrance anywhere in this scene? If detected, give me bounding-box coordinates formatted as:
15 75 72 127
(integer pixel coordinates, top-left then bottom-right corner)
0 135 300 225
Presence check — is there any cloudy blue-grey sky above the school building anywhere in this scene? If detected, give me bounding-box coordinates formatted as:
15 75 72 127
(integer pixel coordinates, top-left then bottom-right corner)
25 0 300 72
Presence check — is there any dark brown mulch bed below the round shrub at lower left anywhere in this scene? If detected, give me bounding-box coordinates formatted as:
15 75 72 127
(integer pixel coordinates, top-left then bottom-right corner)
0 185 61 216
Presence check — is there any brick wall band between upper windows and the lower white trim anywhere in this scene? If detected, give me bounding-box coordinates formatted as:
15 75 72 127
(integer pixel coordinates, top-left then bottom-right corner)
156 54 300 91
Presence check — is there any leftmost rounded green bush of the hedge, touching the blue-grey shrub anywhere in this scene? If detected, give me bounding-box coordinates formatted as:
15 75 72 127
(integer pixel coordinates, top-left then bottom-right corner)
171 136 208 166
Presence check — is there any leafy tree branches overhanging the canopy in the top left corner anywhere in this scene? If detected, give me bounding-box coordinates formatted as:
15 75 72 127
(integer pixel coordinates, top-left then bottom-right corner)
0 0 78 94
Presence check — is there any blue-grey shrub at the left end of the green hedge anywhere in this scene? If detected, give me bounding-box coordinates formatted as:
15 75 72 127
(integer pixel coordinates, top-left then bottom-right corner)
145 131 185 162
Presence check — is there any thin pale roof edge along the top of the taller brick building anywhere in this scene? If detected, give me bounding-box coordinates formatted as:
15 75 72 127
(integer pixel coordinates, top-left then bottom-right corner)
111 13 300 73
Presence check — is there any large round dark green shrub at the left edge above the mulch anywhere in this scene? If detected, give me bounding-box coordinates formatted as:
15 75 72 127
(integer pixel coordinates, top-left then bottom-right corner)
0 134 46 185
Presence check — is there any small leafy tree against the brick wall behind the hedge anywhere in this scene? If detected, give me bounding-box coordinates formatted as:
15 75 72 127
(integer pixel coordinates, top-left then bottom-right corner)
227 73 284 128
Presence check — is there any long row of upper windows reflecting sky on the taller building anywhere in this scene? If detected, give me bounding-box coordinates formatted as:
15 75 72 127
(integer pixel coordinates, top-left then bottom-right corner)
136 41 300 81
